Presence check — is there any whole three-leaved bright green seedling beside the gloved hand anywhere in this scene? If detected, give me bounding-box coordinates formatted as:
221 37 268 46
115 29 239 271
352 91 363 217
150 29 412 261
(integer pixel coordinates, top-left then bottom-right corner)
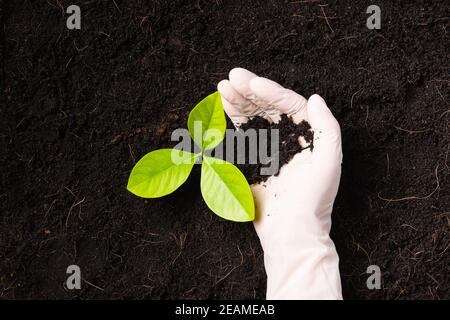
127 92 255 222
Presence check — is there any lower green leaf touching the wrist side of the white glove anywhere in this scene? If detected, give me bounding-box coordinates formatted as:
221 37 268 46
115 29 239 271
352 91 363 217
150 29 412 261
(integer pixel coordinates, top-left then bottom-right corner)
200 156 255 222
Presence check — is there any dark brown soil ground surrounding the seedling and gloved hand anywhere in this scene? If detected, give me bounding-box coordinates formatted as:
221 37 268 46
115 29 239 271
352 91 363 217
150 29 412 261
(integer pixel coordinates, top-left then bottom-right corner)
0 0 450 299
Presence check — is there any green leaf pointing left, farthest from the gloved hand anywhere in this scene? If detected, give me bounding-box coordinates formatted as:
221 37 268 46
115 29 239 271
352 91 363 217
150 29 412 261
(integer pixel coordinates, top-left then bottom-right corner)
127 149 199 198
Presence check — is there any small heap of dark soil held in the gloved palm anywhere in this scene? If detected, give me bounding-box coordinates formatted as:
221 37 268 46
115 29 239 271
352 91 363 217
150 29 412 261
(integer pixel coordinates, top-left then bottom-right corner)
229 114 314 184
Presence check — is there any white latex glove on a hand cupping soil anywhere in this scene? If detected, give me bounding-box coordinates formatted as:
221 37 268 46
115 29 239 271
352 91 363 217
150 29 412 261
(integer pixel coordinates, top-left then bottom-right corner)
218 68 342 299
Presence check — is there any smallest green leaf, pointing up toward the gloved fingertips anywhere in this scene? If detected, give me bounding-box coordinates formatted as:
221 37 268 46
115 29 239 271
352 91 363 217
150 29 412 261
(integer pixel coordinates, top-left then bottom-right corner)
188 91 227 150
